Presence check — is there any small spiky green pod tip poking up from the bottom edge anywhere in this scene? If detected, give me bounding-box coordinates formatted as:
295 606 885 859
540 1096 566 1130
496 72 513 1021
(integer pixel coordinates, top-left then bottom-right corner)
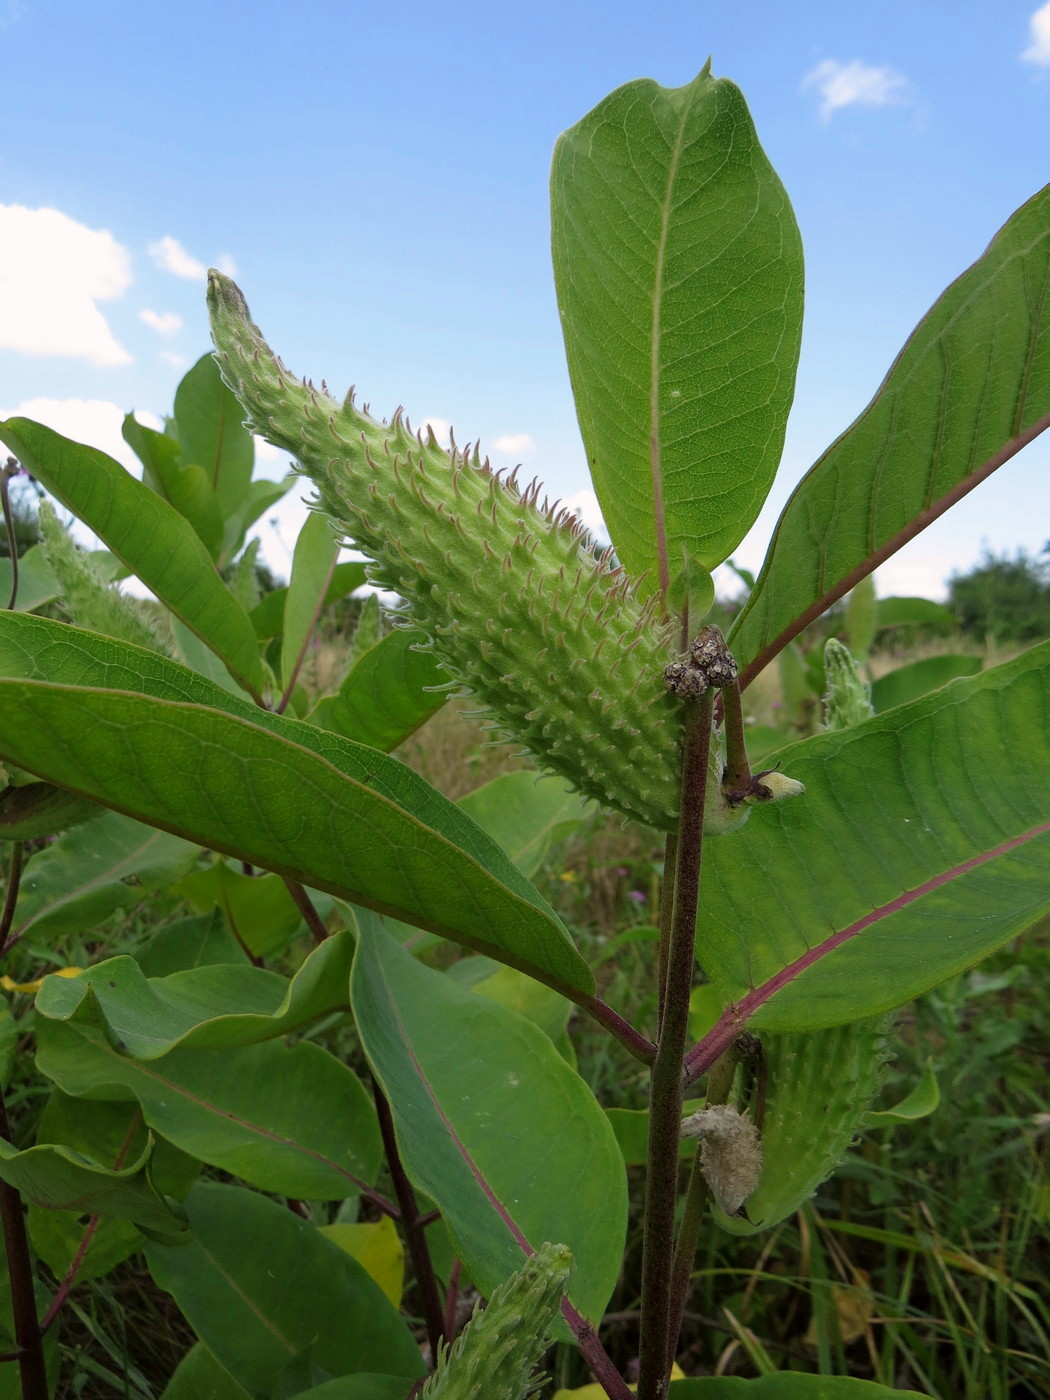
420 1245 573 1400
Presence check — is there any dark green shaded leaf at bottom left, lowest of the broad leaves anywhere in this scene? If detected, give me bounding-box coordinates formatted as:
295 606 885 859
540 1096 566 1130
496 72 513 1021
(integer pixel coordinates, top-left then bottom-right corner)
147 1184 423 1400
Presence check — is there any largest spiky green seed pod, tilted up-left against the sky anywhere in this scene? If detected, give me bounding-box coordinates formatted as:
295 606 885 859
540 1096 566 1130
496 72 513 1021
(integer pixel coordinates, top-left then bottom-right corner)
209 272 767 830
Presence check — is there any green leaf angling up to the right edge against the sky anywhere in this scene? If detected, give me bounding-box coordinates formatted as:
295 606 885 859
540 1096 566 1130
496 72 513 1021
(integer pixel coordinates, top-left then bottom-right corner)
729 185 1050 683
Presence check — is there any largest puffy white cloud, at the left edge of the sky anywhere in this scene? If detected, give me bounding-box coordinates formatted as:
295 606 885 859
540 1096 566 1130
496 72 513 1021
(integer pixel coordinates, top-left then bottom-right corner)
0 204 132 367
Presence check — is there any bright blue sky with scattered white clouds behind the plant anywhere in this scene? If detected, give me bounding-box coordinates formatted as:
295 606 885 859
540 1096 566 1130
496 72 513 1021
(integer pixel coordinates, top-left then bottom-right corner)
0 0 1050 596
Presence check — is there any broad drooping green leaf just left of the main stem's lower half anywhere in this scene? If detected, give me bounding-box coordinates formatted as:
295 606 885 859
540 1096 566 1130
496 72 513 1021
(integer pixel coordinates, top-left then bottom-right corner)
351 924 627 1322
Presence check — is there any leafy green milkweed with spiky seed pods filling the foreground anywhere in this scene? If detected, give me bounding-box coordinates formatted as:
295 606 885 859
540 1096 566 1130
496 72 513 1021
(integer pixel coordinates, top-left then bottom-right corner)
0 64 1050 1400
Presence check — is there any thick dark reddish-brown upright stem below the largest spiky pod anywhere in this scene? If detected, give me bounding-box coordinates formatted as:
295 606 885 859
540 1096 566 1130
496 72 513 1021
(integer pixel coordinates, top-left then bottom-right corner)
638 690 714 1400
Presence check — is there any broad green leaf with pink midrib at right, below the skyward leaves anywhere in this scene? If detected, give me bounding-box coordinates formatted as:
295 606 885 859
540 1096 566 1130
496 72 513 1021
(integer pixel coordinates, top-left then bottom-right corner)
690 643 1050 1068
